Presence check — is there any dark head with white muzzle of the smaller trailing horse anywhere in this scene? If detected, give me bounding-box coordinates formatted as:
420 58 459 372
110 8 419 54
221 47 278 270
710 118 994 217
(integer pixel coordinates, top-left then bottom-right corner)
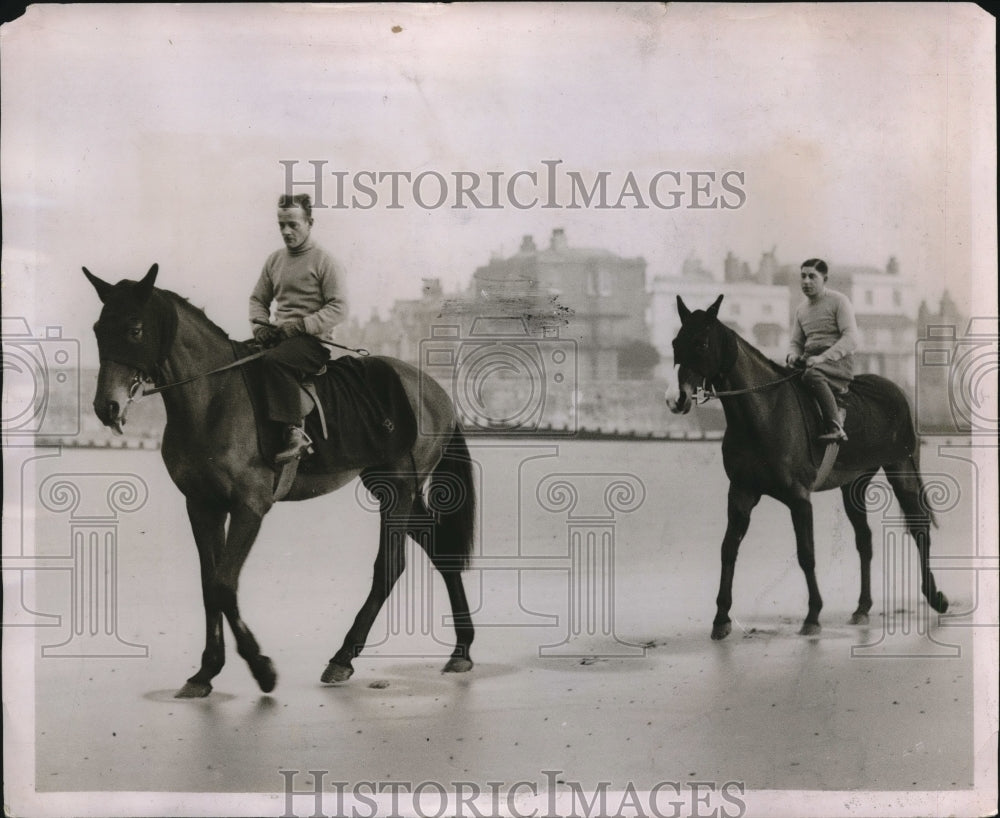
667 295 735 414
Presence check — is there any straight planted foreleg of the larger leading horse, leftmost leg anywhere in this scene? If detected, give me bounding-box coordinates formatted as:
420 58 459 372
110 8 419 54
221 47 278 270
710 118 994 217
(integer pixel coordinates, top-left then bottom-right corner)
175 498 226 699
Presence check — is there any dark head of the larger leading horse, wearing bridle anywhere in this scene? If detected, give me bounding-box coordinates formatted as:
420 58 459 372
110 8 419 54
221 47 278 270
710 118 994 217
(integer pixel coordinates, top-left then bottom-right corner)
83 264 176 434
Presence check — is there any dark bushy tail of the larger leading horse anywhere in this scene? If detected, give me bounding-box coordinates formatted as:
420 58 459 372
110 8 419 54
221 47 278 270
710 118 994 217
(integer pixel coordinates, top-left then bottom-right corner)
426 423 476 571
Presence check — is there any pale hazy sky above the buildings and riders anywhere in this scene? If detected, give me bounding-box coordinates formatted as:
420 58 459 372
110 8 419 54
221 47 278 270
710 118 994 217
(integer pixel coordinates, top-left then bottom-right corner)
0 4 997 363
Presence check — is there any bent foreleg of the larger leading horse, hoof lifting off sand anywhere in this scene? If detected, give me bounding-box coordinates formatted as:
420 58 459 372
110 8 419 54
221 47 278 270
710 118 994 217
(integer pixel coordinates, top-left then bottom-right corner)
213 505 278 693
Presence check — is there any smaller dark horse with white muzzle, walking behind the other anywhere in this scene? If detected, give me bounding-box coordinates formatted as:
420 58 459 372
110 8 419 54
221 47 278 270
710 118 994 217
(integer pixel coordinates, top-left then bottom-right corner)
667 295 948 639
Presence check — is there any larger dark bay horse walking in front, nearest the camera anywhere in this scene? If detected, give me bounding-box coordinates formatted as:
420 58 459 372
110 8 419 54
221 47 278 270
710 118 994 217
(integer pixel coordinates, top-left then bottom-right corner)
84 264 476 698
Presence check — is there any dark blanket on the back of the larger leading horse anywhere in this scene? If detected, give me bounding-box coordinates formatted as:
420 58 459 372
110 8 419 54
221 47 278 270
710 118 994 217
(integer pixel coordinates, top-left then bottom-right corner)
236 347 417 474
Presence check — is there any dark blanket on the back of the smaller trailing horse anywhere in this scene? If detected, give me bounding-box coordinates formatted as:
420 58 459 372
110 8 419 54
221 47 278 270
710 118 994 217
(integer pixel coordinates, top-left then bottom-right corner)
796 375 917 468
